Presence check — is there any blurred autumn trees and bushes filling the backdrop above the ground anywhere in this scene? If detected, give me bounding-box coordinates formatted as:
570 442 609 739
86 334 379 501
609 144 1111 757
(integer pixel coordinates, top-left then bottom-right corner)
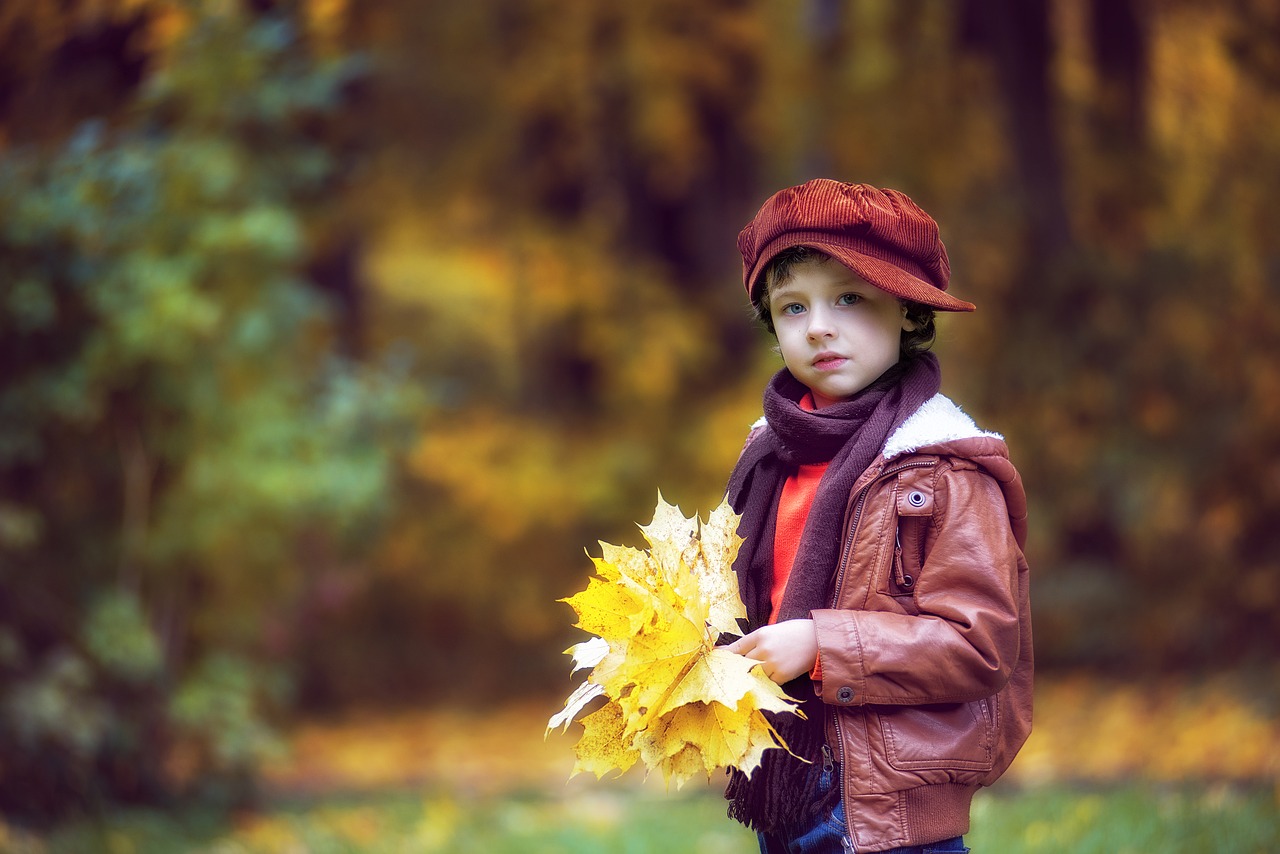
0 0 1280 816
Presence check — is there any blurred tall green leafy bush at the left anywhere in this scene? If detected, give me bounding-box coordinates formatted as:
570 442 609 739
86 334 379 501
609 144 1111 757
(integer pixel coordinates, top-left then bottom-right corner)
0 4 422 816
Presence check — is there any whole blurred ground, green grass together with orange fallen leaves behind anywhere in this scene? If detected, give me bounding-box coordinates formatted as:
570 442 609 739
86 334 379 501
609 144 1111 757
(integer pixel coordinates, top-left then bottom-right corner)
0 677 1280 854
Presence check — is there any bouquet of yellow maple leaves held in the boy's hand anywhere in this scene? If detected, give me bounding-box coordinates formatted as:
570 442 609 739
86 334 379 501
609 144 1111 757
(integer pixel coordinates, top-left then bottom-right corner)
547 494 801 787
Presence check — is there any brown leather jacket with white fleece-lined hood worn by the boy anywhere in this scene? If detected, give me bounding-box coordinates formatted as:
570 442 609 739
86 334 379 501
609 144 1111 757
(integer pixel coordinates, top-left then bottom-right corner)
813 396 1033 851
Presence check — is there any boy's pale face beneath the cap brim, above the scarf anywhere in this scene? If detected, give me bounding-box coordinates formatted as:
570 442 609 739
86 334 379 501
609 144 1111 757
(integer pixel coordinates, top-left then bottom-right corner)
769 259 915 408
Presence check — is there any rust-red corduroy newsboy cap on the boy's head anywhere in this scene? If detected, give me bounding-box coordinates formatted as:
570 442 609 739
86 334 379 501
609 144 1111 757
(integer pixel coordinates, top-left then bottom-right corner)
737 178 977 311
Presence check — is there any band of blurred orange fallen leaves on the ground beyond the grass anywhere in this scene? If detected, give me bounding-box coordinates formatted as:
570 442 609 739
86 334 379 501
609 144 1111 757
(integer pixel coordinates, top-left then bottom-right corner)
259 676 1280 795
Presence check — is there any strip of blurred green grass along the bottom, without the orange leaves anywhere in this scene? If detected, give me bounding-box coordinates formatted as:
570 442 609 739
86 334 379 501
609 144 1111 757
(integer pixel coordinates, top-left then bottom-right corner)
0 782 1280 854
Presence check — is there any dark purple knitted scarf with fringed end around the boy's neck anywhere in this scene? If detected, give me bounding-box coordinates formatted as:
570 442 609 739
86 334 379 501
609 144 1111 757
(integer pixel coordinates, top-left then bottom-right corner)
724 353 941 832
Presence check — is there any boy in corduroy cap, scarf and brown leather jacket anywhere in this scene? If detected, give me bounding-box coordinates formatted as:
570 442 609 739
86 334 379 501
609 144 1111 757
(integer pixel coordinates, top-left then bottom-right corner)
726 179 1032 854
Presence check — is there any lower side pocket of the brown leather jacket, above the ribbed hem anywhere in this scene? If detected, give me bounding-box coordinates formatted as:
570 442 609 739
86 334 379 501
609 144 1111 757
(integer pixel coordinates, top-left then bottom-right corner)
879 697 997 771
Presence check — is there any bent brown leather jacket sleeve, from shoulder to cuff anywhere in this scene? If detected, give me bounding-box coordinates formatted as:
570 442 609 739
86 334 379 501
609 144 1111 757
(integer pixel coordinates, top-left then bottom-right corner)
813 467 1023 705
